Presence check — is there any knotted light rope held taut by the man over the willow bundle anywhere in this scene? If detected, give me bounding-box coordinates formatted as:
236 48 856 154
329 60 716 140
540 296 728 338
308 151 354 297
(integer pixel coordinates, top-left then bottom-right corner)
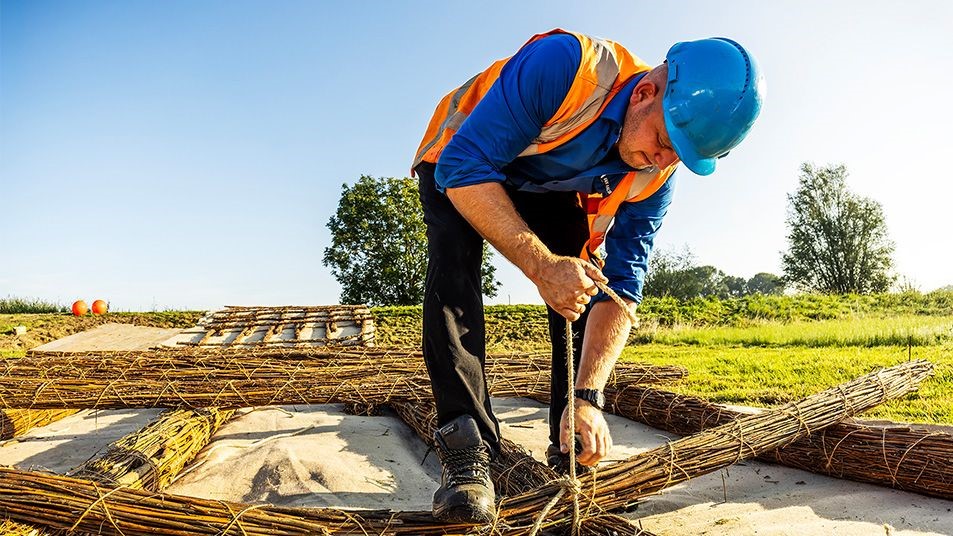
529 281 639 536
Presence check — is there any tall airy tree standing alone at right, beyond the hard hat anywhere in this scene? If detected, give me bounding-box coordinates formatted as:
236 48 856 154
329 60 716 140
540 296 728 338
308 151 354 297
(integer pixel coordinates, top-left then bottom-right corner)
782 163 894 294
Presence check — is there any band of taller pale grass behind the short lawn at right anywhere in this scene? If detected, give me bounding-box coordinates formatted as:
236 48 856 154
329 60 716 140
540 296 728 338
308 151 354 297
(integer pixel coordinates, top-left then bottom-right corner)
631 315 953 348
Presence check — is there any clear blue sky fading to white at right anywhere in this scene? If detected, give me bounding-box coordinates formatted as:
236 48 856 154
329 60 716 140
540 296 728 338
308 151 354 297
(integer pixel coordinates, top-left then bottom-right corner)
0 0 953 310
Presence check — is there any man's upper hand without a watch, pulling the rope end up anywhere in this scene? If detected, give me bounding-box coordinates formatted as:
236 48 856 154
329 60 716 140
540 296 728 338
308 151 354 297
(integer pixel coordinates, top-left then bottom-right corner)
533 256 609 322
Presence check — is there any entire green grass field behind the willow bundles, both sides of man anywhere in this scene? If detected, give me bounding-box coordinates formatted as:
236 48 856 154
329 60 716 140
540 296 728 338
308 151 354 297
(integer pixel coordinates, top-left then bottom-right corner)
0 292 953 424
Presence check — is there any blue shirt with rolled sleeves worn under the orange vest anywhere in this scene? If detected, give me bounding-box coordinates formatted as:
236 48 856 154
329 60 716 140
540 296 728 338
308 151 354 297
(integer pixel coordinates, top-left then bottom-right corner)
435 34 674 303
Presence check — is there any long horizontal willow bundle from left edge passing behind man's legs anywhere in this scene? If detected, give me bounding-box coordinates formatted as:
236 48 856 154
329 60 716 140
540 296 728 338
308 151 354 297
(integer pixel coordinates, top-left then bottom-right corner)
0 350 684 409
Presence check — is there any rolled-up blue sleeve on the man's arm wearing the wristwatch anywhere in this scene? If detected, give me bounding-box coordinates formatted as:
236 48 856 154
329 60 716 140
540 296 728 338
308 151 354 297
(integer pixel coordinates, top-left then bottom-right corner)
593 175 675 303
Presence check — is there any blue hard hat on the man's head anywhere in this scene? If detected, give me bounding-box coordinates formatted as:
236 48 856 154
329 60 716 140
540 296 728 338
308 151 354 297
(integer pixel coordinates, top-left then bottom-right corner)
662 37 765 175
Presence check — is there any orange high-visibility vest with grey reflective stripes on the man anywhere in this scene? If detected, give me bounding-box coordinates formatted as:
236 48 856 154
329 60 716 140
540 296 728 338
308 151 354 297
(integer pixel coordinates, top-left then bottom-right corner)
411 28 675 266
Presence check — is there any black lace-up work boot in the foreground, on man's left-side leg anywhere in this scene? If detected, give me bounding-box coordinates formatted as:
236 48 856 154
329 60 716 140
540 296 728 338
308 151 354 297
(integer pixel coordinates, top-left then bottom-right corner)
433 415 496 523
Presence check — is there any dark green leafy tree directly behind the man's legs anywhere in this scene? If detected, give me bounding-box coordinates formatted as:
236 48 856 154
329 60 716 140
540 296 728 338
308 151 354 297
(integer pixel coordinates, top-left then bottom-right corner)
323 175 500 305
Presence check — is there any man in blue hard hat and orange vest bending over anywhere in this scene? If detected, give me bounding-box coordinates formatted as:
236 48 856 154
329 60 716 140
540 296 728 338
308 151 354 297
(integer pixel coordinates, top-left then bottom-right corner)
413 30 763 523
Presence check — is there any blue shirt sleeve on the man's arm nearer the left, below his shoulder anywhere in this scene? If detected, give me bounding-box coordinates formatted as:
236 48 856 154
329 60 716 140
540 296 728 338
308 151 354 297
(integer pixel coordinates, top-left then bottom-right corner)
434 34 582 192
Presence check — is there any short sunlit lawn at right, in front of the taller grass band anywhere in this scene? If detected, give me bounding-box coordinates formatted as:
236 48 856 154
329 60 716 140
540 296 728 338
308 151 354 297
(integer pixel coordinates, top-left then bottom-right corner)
622 344 953 424
